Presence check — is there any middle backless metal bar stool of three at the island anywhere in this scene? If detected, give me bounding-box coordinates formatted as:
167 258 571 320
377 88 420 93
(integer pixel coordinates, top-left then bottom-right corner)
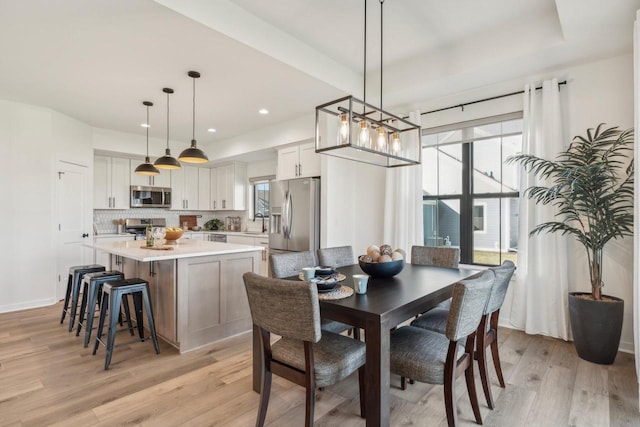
76 270 125 347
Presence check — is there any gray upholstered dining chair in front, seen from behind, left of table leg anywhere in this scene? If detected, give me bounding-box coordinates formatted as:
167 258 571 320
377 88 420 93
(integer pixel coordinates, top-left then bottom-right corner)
243 272 366 427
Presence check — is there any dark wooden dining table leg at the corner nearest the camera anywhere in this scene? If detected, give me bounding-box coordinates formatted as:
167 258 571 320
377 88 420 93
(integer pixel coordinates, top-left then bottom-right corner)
365 323 391 427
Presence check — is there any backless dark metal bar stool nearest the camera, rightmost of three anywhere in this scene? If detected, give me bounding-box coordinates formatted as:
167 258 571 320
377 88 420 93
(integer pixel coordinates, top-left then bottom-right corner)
93 278 160 370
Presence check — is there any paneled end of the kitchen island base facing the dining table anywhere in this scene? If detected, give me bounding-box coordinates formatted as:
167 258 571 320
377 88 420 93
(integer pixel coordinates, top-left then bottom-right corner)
177 252 260 353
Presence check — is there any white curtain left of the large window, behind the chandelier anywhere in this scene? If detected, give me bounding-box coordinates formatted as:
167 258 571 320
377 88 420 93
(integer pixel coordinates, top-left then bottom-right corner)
384 111 424 256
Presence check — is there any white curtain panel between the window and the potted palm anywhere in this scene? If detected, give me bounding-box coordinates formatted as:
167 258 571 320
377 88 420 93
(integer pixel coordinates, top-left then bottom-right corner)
510 79 569 340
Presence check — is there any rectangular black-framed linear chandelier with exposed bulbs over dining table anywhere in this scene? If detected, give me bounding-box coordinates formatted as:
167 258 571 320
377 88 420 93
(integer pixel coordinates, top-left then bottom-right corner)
315 0 422 167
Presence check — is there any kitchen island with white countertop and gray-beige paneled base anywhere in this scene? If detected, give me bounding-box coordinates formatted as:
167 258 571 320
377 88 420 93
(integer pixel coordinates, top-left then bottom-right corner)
85 239 264 353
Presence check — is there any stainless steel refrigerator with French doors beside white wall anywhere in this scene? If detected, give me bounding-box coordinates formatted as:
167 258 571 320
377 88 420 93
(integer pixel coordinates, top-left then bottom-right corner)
269 178 320 253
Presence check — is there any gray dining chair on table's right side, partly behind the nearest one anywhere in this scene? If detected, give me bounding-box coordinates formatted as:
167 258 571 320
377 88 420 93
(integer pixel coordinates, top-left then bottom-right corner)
411 260 516 409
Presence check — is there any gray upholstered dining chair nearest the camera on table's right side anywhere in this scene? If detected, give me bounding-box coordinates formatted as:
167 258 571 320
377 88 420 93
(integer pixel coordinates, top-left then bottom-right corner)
390 270 495 426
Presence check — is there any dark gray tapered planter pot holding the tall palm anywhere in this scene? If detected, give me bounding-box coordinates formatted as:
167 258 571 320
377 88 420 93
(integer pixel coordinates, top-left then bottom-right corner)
569 292 624 365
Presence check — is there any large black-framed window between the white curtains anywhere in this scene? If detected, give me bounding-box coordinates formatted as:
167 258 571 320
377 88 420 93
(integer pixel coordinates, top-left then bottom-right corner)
422 113 522 265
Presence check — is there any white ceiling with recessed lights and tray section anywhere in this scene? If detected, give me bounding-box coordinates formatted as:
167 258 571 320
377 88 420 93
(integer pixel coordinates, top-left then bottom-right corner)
0 0 640 151
